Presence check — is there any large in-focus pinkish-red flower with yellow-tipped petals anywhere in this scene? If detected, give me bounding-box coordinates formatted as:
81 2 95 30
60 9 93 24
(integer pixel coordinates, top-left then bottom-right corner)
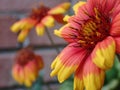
51 0 120 90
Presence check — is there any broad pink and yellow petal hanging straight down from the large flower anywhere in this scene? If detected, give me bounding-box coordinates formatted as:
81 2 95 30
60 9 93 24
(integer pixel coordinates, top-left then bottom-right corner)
83 56 105 90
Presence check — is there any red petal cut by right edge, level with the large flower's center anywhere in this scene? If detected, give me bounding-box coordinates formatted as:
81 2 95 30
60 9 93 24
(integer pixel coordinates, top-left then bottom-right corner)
110 13 120 36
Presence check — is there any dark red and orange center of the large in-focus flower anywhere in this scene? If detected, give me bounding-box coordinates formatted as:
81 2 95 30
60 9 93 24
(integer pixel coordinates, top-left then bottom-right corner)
71 9 110 49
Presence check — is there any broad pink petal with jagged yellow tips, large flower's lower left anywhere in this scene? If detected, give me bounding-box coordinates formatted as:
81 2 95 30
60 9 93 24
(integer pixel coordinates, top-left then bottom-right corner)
51 44 87 82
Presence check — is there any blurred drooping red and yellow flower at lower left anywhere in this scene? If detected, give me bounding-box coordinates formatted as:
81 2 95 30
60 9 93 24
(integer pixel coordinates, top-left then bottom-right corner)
12 49 44 87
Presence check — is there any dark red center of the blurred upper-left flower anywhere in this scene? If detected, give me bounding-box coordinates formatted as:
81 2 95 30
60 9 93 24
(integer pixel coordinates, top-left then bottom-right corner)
30 5 50 22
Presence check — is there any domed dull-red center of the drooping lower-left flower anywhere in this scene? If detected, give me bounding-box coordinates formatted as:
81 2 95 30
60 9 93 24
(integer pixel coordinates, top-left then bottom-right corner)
15 49 35 66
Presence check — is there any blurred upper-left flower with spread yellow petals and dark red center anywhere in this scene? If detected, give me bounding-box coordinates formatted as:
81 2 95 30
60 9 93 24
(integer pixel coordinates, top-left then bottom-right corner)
11 2 70 42
